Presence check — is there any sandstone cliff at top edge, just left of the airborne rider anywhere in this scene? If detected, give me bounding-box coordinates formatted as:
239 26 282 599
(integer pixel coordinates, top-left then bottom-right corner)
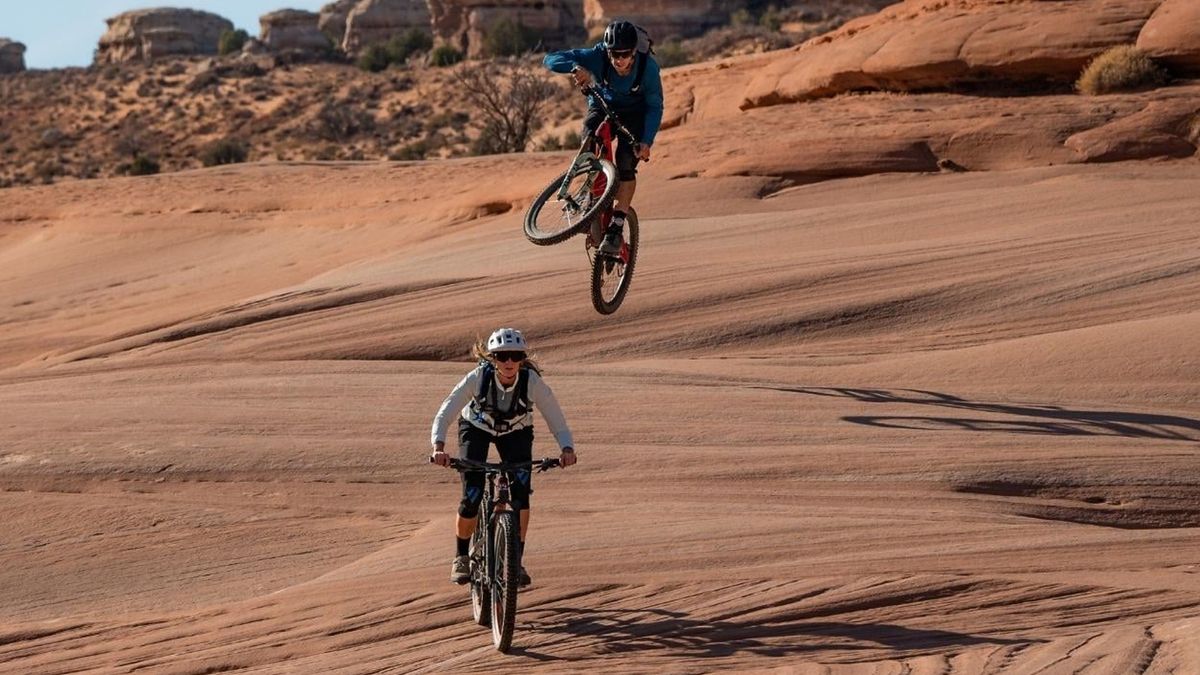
430 0 584 56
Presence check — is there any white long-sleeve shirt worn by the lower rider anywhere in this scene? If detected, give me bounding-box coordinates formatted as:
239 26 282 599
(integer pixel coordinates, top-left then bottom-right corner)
431 366 575 449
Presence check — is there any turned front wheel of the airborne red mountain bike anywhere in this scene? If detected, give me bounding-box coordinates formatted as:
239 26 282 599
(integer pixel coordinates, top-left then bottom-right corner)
524 159 617 246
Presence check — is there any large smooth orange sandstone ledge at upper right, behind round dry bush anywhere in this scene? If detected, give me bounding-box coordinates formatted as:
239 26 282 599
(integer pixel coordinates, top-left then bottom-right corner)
742 0 1200 108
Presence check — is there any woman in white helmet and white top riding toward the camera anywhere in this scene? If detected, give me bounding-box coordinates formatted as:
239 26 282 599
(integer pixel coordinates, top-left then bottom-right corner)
430 328 576 586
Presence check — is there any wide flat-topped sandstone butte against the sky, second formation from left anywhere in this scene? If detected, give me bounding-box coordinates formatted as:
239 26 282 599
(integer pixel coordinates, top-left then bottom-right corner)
95 8 233 64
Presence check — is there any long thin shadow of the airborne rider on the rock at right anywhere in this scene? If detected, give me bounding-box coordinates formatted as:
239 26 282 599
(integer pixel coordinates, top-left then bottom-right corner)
760 387 1200 442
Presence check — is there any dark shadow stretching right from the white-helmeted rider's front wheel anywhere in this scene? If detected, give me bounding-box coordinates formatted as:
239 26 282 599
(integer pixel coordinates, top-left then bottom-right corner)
514 607 1037 661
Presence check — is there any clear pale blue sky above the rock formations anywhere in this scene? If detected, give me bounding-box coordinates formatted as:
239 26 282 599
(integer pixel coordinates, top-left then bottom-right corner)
9 0 329 68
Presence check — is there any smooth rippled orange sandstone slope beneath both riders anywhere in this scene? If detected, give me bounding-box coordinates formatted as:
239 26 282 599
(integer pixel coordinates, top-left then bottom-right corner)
0 155 1200 675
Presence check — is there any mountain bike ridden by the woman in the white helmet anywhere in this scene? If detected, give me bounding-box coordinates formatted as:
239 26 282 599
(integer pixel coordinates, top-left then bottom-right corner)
450 458 559 653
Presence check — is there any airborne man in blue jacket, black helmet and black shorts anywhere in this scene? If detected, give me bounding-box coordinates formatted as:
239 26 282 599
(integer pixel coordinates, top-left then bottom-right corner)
544 20 662 256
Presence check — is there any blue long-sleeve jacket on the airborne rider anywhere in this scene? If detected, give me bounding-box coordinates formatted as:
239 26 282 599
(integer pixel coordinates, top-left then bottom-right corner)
542 43 662 145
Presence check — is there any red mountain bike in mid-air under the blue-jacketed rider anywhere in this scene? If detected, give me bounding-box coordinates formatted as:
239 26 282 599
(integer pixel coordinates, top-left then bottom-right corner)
524 85 638 315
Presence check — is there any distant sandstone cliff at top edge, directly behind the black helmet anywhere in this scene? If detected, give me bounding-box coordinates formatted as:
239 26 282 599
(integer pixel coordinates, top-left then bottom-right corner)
583 0 729 41
